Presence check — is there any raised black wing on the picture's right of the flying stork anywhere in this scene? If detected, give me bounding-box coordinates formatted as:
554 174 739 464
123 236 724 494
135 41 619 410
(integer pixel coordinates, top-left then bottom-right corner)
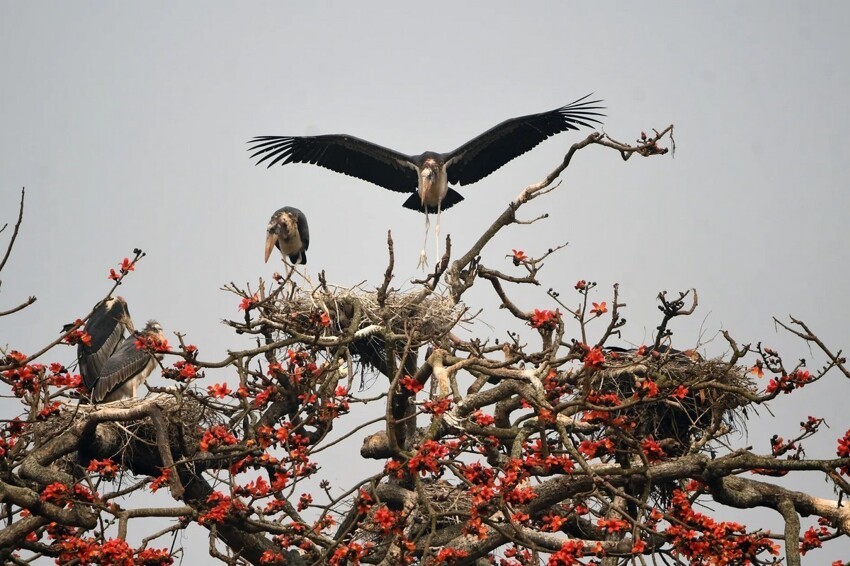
445 94 604 185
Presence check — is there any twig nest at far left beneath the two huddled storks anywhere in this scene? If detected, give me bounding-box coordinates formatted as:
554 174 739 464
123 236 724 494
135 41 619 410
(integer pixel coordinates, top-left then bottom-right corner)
33 393 209 482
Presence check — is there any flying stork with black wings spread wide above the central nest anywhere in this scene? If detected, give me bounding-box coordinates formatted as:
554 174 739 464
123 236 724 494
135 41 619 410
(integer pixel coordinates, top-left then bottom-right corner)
249 95 603 266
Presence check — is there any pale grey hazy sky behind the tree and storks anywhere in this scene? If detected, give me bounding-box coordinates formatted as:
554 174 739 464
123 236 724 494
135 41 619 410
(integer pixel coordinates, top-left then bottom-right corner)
0 0 850 562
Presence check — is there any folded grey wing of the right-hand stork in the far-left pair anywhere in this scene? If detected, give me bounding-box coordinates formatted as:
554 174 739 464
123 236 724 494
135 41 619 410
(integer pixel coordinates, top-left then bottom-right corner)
92 336 156 403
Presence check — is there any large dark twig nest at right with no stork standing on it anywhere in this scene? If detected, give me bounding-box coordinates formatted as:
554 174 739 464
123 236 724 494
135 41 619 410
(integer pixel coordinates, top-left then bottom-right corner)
592 351 754 451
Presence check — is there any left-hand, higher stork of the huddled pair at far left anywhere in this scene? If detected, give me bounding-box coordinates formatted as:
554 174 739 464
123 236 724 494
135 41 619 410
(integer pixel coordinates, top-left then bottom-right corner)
77 297 135 391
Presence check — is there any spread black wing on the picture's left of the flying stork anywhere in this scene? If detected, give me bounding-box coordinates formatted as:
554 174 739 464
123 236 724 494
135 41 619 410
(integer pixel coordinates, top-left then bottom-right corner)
248 134 418 193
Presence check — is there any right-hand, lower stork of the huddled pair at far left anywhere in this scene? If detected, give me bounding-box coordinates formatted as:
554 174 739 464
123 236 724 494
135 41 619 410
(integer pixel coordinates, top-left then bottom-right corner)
89 320 165 403
